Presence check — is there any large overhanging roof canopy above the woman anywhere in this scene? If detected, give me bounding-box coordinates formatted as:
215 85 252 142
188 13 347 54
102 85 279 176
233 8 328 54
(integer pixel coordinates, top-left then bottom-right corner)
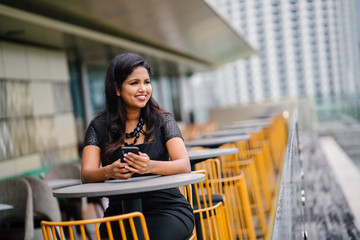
0 0 254 67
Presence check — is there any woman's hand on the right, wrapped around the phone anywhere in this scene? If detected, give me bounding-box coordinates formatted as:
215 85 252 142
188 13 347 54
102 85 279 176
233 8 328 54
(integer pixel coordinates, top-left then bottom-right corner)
124 152 151 174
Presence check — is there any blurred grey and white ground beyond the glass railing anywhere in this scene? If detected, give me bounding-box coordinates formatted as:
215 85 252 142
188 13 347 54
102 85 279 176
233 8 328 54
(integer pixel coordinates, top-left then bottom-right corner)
300 131 360 240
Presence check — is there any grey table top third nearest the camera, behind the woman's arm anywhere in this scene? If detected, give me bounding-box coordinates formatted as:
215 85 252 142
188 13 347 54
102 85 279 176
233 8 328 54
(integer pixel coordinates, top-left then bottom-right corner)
185 134 250 148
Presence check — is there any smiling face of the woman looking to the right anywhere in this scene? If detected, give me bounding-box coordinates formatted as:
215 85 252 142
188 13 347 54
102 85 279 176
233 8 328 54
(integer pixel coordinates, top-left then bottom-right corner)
116 66 152 109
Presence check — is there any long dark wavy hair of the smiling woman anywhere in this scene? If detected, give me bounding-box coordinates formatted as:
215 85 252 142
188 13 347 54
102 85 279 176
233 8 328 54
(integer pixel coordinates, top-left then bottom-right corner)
101 53 164 161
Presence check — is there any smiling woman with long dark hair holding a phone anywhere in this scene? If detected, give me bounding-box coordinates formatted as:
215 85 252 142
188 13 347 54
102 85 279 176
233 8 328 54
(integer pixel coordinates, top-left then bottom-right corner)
81 53 194 240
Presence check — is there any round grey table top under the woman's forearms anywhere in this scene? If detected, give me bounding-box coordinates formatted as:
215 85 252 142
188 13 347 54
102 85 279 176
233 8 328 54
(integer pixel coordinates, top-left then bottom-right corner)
53 173 205 198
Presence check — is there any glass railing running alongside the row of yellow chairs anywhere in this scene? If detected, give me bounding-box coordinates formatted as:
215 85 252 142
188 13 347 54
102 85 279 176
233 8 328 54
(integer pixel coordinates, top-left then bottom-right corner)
271 106 307 240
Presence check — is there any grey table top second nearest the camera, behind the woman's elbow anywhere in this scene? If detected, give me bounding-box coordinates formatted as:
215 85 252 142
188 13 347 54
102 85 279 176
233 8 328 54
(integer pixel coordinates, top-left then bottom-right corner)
188 148 238 161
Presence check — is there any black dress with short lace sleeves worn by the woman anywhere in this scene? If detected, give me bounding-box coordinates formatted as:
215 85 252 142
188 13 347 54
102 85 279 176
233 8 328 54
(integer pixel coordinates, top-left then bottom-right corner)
84 113 194 240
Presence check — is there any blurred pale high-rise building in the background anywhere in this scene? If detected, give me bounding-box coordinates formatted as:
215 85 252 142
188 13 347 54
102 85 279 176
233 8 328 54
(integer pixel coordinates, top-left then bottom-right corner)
197 0 360 118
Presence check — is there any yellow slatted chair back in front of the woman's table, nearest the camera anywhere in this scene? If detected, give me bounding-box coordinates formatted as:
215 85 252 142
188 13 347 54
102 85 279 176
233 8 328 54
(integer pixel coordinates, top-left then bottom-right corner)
41 212 150 240
